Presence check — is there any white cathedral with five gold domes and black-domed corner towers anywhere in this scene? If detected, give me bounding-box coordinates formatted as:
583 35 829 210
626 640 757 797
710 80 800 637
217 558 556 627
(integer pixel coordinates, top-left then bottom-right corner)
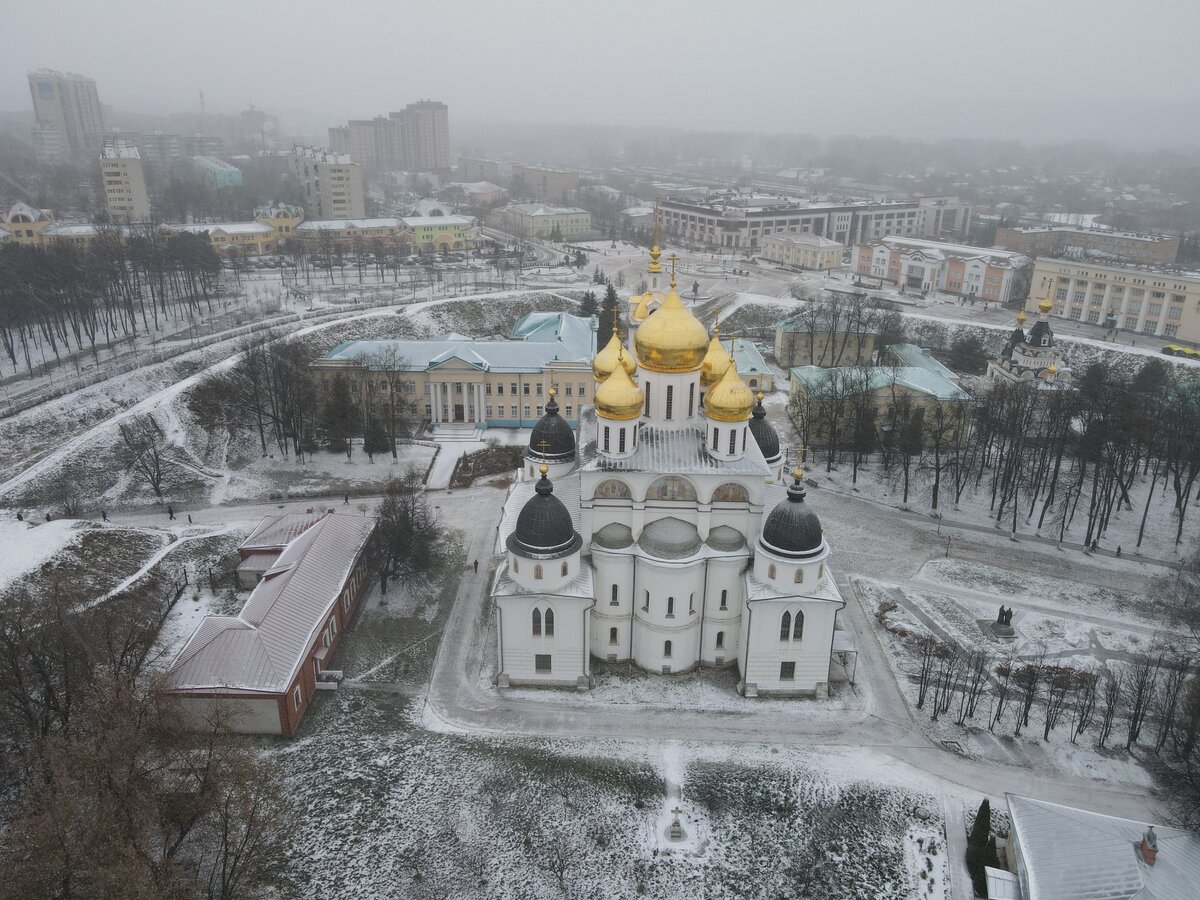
492 240 847 697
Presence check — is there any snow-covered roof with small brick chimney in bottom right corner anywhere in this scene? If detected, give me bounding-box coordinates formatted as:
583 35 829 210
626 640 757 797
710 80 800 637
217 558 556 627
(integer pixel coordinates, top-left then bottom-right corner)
1006 793 1200 900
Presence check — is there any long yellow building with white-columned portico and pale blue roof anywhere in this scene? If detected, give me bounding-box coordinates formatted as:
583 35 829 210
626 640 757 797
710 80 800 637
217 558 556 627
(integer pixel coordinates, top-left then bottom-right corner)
313 312 595 428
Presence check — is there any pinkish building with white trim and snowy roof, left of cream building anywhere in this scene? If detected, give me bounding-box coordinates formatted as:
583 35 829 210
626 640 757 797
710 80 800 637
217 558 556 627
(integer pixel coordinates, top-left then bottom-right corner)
851 236 1030 304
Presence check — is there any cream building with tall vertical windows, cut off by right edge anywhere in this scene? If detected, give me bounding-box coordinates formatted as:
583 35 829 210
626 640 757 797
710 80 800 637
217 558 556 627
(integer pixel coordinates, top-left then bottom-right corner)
1030 258 1200 343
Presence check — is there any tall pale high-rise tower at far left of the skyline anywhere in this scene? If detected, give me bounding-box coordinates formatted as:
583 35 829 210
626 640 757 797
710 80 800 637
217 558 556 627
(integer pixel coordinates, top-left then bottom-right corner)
29 68 104 163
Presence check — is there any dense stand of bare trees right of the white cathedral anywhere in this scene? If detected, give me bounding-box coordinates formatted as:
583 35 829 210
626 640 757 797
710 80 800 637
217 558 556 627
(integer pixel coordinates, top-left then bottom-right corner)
790 359 1200 547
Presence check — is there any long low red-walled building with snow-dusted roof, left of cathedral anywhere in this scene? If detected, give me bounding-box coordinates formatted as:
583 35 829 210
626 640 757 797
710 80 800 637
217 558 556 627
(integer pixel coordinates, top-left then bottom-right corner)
167 511 376 737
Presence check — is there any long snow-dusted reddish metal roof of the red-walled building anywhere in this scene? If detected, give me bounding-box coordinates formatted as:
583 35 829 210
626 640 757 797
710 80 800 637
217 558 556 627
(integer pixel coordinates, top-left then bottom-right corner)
167 512 376 694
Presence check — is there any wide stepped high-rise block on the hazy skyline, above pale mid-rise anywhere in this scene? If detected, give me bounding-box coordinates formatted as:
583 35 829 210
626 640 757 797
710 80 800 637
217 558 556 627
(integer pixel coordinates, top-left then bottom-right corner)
329 100 450 172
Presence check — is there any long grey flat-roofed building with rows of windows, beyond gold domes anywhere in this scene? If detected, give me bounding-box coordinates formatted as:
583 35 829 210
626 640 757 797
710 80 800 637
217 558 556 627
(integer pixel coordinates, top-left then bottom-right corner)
658 194 928 250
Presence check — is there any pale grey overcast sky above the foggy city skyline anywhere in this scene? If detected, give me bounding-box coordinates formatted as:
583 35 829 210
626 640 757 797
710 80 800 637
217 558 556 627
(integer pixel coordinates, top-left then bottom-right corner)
0 0 1200 146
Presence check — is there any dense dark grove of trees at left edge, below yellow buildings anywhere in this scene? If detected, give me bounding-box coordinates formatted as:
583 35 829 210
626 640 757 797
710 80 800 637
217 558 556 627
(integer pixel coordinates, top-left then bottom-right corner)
0 234 221 372
